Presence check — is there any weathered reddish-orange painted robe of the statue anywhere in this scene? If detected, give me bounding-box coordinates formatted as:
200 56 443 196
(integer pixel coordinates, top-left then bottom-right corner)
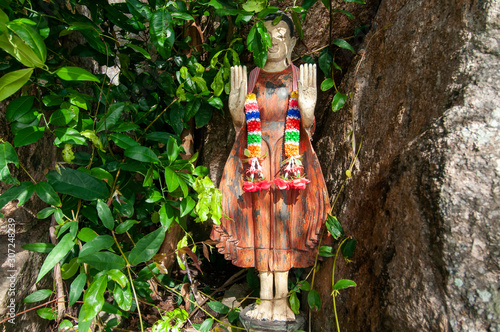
211 67 330 271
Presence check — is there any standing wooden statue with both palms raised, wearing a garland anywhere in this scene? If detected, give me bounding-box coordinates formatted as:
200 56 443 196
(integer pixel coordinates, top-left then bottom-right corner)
211 15 330 321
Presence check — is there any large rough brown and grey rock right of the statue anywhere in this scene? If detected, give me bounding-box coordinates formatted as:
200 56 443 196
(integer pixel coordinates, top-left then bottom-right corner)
313 0 500 331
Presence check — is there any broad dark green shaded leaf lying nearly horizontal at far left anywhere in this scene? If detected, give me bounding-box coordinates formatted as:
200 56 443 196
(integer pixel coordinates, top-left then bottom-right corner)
46 168 109 201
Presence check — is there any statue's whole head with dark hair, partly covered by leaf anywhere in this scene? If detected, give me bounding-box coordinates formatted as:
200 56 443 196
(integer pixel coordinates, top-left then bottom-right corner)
264 14 297 65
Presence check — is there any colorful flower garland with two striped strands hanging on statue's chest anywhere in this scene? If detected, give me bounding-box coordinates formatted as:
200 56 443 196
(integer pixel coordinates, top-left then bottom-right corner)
243 91 310 192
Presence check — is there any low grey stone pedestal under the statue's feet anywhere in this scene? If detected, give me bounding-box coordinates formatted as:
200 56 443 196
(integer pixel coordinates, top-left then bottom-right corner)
240 303 306 332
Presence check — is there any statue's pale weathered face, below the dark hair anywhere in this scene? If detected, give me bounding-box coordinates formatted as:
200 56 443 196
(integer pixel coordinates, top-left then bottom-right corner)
264 21 295 62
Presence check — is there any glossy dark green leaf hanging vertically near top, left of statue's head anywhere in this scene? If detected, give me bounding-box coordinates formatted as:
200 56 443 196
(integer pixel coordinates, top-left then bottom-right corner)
149 7 175 59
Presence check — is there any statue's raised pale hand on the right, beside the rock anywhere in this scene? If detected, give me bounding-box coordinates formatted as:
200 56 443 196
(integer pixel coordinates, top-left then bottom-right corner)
298 64 318 132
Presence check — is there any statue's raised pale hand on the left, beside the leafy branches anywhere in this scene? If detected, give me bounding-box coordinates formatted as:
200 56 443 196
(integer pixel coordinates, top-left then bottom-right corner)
229 66 247 131
